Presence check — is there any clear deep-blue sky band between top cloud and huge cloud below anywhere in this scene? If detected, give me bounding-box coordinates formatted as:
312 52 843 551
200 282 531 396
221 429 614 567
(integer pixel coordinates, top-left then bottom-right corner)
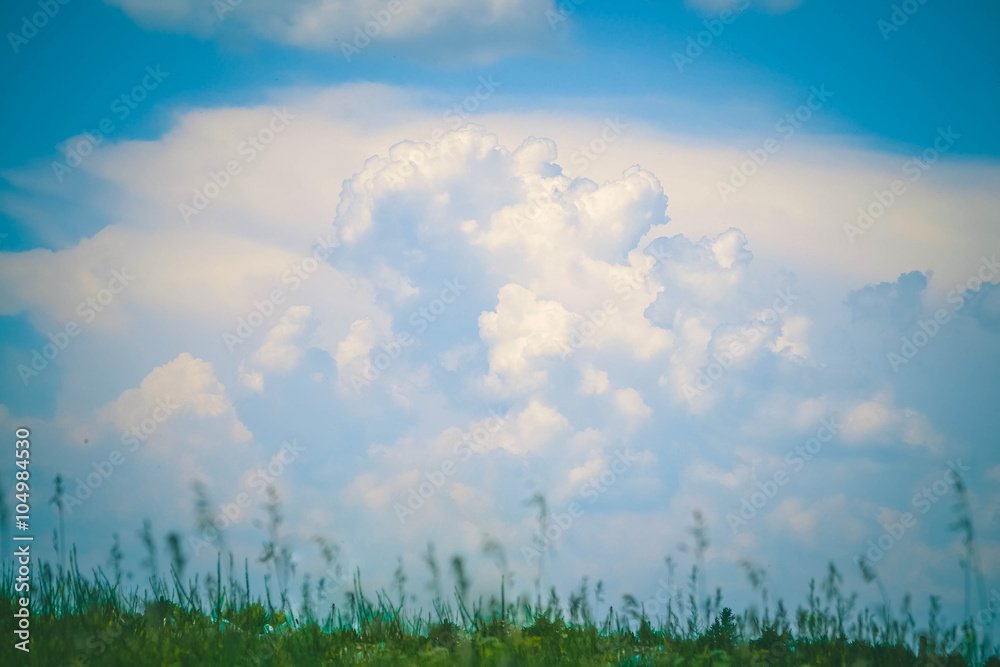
3 2 1000 175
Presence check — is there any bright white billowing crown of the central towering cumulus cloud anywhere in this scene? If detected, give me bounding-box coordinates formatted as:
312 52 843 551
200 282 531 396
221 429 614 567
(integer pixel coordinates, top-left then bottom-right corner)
337 126 670 400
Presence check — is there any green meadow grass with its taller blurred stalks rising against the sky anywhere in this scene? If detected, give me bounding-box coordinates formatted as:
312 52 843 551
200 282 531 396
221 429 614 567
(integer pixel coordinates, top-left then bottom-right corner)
0 484 1000 667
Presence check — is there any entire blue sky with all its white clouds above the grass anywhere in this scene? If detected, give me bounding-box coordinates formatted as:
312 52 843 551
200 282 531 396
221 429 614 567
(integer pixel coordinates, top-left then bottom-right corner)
0 0 1000 636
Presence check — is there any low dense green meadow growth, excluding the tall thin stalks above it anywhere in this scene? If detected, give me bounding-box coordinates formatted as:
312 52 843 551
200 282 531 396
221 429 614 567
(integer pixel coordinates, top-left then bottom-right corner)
0 554 1000 667
